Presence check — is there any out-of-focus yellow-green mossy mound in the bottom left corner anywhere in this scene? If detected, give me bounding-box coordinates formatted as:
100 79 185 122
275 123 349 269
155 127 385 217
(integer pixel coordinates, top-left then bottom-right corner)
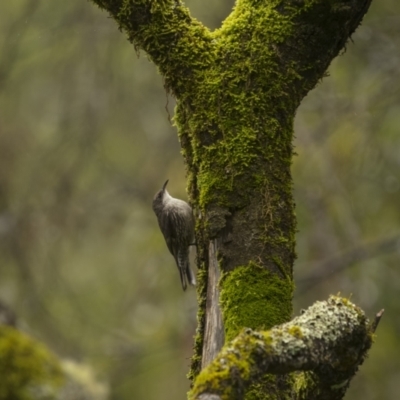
0 326 64 400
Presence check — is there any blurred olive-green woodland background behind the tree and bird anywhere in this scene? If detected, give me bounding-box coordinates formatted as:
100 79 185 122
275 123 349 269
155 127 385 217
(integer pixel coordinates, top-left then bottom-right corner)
0 0 400 400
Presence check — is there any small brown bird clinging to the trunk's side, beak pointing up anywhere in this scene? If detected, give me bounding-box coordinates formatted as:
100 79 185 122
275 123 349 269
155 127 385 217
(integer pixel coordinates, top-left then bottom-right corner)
153 180 196 290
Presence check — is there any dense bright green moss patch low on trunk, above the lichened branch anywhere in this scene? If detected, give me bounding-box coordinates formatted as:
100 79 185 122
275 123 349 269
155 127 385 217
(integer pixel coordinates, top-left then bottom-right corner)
220 263 293 341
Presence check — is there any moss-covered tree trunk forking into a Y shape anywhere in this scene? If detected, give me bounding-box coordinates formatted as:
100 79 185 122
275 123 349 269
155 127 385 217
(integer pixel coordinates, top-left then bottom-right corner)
89 0 371 398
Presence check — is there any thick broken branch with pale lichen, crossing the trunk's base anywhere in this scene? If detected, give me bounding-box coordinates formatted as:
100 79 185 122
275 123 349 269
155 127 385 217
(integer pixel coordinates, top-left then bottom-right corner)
190 296 381 400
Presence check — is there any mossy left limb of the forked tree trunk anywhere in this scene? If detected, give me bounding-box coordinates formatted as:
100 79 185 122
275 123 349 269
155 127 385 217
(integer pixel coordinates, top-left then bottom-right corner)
92 0 212 97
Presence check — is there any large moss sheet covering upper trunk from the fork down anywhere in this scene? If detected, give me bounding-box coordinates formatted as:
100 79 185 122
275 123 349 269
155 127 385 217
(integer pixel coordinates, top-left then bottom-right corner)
171 1 299 216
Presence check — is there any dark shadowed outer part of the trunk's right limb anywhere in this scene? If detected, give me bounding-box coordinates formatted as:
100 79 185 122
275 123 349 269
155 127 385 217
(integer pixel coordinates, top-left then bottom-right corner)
278 0 372 101
